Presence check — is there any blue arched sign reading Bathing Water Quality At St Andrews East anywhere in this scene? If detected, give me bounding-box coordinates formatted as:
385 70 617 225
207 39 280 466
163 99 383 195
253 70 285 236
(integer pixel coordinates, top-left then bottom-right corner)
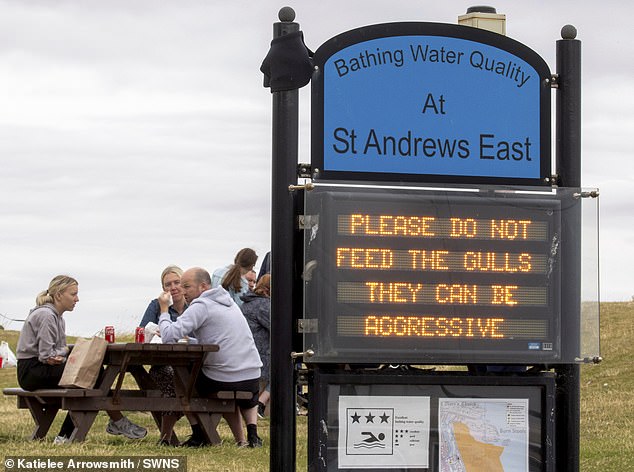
313 23 550 184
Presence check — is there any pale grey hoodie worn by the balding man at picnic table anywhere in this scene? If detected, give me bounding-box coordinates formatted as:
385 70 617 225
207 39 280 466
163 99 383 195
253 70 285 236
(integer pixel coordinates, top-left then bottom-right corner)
159 287 262 382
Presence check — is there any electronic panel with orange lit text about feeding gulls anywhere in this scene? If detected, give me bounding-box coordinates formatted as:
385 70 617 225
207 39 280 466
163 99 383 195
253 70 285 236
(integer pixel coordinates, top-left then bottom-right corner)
304 186 572 363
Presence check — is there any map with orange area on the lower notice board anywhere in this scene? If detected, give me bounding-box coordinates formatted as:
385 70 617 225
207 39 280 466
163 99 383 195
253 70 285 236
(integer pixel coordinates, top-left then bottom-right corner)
438 398 529 472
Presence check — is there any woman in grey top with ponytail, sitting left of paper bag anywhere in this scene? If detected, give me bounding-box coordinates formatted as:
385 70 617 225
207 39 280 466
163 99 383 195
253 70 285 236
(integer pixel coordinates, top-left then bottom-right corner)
16 275 147 444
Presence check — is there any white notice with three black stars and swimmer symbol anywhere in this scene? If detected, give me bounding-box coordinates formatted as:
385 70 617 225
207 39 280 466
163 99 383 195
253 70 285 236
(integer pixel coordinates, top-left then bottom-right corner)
338 395 430 469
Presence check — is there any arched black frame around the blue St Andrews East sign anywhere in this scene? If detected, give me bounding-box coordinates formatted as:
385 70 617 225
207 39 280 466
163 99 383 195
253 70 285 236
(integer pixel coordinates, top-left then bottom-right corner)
311 22 552 185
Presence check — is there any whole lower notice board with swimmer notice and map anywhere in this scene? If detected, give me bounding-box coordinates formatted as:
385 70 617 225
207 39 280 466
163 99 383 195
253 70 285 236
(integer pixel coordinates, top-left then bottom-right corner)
308 367 555 472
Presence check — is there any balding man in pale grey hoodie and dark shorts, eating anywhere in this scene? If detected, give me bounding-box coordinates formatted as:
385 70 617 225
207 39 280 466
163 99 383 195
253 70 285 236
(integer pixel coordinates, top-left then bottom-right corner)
158 267 262 447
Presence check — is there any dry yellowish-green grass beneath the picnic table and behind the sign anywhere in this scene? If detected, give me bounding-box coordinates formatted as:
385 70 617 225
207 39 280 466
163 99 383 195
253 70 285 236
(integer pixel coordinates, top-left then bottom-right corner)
0 303 634 472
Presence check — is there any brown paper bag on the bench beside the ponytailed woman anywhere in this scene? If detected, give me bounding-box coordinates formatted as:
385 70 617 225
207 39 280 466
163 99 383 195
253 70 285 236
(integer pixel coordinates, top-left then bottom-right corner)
59 337 108 388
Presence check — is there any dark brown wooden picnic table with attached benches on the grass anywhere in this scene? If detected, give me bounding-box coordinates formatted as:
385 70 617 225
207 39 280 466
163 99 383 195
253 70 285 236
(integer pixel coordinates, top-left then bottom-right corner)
3 343 249 444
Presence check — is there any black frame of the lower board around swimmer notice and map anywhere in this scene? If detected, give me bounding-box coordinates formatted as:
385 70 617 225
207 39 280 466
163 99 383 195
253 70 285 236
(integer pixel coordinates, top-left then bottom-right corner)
308 367 556 472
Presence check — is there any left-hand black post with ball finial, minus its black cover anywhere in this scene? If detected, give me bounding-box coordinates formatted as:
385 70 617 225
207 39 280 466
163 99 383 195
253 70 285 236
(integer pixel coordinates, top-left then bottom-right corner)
270 7 299 472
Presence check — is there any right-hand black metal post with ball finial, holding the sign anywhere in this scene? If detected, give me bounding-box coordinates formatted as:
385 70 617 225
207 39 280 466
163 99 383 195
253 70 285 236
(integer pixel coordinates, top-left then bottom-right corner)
555 25 581 472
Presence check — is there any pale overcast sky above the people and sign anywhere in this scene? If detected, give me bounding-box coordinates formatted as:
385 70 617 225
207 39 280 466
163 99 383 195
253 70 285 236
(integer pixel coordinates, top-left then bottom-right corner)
0 0 634 335
